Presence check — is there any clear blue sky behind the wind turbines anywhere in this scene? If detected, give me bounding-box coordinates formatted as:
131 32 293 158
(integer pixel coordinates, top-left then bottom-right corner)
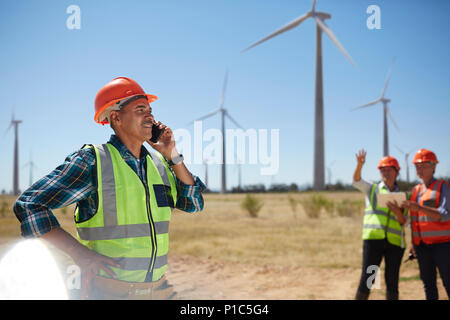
0 0 450 191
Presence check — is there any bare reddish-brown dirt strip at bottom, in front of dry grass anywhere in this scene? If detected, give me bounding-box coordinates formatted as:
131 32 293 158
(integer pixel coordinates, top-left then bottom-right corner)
167 255 446 300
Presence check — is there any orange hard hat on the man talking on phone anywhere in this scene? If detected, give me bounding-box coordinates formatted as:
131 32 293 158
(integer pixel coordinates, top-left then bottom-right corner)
94 77 158 124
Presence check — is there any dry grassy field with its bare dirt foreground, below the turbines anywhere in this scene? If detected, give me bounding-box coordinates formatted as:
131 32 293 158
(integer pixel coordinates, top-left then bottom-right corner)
0 192 446 299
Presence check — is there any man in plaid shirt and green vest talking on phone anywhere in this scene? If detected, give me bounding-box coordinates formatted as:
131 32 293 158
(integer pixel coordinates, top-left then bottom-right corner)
14 77 205 299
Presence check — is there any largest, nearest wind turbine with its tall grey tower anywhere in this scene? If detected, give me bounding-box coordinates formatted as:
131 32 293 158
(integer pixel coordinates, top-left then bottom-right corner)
241 0 355 190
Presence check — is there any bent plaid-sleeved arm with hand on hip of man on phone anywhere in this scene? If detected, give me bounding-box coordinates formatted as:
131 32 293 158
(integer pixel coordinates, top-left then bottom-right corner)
13 150 116 276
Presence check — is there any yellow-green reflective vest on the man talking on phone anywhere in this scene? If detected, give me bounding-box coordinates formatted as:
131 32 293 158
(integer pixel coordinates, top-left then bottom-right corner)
75 143 177 282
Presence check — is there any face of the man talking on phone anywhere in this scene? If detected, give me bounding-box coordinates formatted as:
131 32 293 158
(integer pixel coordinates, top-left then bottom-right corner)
111 98 154 141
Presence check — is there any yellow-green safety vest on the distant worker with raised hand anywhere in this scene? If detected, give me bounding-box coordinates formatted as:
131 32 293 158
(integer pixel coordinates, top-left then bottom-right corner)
362 183 405 248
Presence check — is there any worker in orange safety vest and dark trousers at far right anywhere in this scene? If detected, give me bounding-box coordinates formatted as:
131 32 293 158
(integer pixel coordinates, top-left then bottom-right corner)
403 149 450 300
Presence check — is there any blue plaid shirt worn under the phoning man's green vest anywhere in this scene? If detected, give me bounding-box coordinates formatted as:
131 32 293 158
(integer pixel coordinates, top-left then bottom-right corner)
13 135 206 238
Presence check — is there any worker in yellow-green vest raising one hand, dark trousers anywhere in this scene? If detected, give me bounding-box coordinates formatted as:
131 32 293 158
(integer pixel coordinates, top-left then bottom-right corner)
353 150 407 300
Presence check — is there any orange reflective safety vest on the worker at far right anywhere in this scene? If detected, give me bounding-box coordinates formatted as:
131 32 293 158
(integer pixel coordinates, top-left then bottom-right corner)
410 180 450 245
